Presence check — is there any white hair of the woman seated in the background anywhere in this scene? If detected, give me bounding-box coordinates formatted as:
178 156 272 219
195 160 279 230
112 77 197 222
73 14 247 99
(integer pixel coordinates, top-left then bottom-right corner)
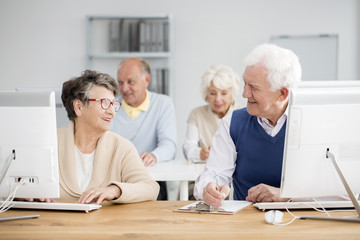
200 65 240 101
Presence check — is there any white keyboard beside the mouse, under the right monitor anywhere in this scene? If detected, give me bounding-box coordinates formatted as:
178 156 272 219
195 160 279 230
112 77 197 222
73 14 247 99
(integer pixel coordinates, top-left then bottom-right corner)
254 201 360 210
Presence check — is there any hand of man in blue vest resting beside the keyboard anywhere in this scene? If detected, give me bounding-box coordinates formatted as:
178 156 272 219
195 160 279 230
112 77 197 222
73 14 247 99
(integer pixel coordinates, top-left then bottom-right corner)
246 184 288 202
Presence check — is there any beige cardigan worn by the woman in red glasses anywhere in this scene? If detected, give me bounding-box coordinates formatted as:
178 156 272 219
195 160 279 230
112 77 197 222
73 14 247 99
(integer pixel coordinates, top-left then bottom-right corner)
58 123 159 203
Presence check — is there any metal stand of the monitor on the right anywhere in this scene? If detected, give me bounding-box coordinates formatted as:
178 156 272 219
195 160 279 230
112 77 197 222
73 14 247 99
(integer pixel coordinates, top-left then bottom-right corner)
300 149 360 223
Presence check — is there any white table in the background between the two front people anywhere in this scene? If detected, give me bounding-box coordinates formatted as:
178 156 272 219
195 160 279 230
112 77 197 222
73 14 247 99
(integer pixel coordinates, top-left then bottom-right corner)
146 159 205 201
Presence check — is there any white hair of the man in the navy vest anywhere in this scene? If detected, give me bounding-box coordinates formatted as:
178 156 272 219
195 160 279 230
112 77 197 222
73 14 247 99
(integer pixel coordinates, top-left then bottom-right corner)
244 43 301 91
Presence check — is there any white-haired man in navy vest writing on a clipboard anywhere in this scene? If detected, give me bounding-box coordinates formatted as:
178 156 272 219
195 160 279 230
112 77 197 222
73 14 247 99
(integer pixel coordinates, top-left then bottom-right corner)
194 44 301 207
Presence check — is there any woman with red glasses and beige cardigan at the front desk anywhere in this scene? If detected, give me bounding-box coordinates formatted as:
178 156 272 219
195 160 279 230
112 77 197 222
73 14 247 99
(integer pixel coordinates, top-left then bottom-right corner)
58 70 159 203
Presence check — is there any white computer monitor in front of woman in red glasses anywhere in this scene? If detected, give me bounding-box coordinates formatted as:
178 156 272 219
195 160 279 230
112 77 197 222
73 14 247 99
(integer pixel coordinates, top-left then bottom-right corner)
0 92 60 198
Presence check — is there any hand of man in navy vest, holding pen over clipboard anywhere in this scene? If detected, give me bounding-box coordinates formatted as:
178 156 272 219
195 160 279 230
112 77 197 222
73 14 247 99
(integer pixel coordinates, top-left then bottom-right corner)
203 182 230 208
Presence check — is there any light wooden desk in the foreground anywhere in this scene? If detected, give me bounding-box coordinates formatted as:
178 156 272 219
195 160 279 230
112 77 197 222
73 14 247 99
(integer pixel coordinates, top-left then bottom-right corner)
0 201 360 240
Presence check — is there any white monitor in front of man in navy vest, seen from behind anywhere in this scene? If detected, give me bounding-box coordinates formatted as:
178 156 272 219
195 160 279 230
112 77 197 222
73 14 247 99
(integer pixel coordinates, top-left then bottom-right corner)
280 86 360 198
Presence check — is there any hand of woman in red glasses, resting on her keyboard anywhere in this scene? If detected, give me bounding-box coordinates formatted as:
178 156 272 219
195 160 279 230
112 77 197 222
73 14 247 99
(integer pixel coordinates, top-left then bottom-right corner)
79 185 121 204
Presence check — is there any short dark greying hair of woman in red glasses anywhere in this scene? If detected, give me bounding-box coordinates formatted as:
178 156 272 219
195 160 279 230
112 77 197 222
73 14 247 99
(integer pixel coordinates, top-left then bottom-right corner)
61 70 119 122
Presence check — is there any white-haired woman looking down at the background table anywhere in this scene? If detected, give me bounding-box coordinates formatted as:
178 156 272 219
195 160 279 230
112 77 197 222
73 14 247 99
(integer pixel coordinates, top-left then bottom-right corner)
183 65 240 160
